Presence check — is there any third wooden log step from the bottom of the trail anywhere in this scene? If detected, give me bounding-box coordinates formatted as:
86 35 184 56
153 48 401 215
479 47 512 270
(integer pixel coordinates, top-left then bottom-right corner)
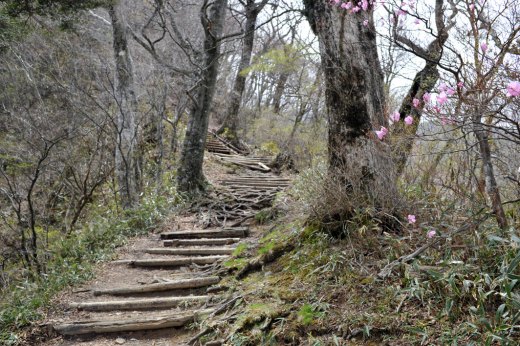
92 276 220 296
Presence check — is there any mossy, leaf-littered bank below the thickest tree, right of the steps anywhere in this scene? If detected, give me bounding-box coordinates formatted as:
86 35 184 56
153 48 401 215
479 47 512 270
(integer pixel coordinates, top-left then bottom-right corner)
196 212 514 345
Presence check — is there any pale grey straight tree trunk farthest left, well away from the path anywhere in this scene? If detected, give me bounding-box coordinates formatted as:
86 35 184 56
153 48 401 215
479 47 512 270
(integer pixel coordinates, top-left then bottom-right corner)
108 2 140 209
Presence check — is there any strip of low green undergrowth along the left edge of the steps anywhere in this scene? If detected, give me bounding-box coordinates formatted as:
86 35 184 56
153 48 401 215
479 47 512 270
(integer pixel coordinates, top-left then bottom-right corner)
0 194 179 345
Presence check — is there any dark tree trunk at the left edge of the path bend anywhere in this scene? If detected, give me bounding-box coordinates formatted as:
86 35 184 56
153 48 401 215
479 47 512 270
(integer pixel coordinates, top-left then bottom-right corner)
177 0 227 193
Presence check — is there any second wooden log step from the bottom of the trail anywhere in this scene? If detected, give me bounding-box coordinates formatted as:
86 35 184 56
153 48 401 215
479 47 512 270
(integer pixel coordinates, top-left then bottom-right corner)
69 295 212 311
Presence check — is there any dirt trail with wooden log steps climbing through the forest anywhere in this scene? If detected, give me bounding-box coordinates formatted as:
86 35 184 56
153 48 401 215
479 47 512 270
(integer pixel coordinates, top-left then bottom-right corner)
42 136 289 346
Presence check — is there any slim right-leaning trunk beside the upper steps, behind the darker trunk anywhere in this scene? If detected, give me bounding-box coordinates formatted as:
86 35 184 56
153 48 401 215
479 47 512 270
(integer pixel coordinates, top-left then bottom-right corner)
218 0 267 145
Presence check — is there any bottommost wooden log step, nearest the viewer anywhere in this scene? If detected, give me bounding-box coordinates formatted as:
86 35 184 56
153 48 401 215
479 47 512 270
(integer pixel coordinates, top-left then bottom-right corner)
54 309 213 335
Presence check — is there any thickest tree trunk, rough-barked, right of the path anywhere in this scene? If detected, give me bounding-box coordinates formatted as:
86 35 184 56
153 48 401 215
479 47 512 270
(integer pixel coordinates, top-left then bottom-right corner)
304 0 397 221
